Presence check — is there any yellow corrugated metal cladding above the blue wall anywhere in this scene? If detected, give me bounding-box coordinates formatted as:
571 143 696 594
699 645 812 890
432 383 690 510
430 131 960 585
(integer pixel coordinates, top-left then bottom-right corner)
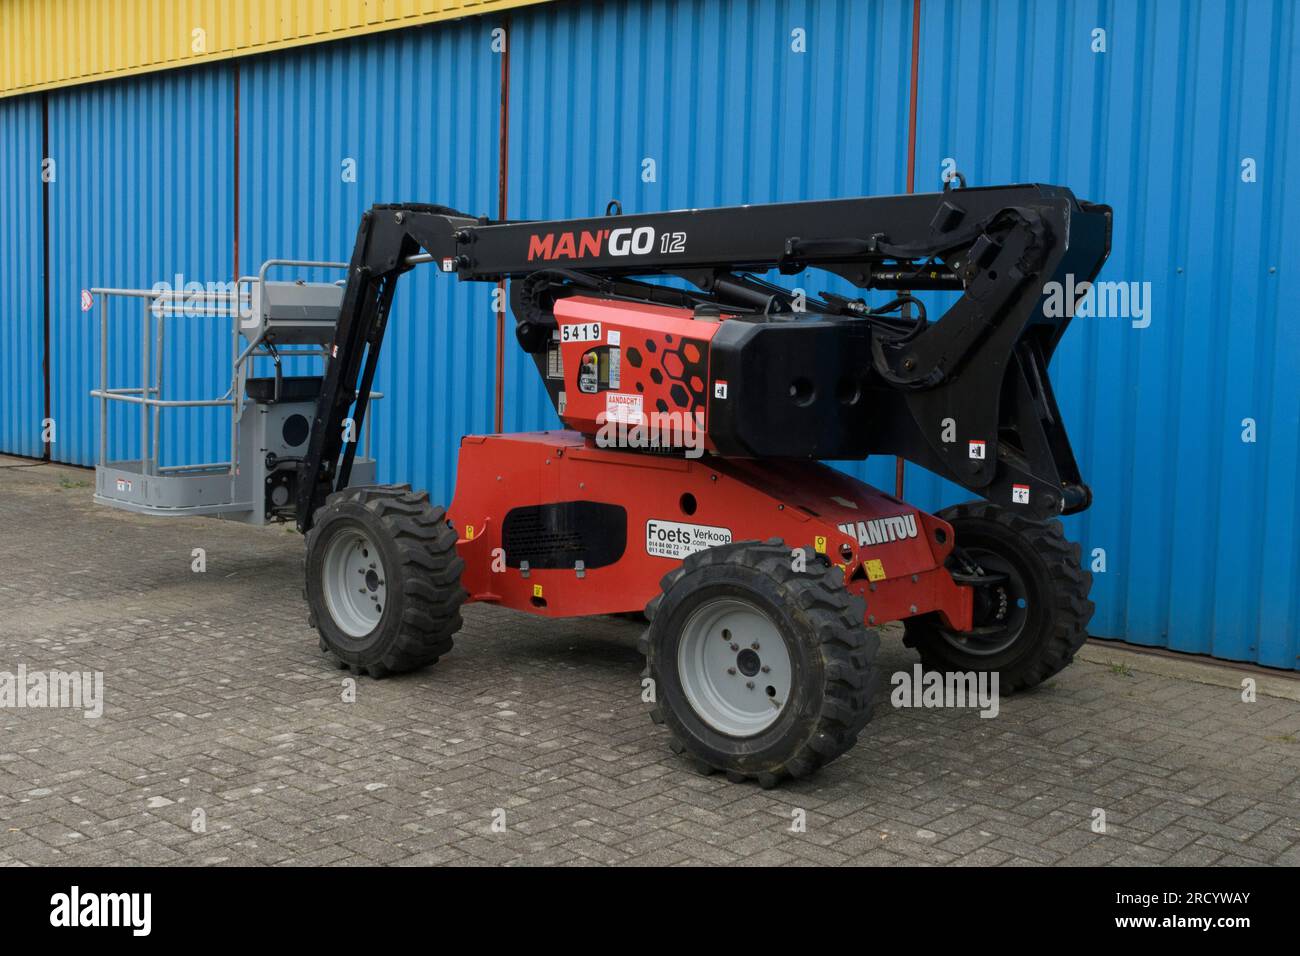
0 0 549 98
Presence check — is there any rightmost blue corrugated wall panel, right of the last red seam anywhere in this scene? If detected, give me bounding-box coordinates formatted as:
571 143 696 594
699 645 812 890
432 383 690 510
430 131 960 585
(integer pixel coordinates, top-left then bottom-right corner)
909 0 1300 667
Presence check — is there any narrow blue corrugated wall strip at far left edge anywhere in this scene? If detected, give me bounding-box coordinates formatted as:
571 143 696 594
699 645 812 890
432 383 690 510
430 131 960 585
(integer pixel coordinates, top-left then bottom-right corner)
0 96 44 457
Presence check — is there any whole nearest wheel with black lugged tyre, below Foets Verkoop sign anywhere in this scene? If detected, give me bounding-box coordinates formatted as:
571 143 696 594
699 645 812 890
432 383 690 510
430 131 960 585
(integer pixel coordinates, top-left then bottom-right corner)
641 541 879 787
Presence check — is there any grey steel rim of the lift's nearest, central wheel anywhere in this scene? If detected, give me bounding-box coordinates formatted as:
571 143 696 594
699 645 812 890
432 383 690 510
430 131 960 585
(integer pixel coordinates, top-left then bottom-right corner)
677 597 794 737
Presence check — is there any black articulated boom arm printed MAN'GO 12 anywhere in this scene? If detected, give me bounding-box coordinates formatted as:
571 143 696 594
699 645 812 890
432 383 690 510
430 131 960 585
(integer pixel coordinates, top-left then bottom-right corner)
298 185 1110 531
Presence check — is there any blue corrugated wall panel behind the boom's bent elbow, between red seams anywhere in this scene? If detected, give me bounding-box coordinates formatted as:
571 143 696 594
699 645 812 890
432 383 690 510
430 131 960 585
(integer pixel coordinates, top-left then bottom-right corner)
239 20 501 502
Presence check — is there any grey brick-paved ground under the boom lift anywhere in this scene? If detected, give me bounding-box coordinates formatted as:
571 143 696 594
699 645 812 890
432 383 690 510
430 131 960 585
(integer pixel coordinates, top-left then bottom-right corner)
0 459 1300 865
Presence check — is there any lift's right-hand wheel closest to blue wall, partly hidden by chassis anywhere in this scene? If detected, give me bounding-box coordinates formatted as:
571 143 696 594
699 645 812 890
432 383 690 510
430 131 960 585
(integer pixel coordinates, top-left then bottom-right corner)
904 501 1093 693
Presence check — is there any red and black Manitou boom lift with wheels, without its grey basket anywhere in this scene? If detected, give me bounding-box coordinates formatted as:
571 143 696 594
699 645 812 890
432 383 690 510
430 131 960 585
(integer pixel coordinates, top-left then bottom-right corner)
94 185 1110 786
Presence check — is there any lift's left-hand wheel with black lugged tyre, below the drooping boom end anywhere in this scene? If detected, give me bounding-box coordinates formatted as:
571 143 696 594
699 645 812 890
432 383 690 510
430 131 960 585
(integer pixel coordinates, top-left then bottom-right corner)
304 485 465 678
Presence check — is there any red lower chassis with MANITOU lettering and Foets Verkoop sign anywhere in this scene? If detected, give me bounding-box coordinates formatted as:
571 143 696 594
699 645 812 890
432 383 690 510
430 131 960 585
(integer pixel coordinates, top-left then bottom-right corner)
449 432 974 631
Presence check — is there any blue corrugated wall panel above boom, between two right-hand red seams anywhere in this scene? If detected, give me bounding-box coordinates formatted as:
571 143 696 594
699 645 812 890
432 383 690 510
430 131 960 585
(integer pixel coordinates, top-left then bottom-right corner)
506 0 911 488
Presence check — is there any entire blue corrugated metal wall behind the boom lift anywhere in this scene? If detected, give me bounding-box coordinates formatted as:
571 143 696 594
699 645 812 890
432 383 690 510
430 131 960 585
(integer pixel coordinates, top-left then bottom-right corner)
0 0 1300 667
